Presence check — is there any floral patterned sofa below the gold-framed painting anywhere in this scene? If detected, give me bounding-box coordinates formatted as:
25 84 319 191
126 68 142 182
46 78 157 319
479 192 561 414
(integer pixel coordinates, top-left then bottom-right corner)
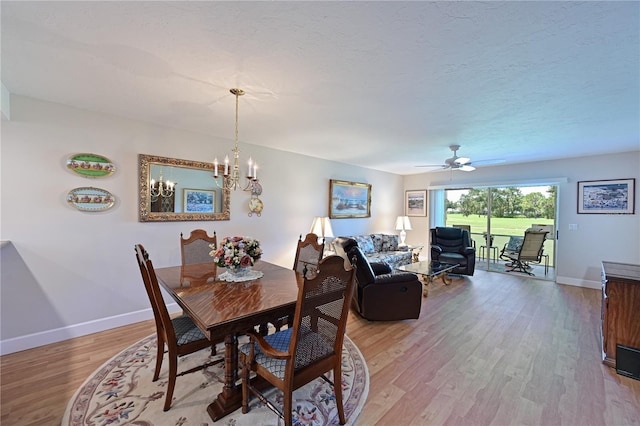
332 234 412 269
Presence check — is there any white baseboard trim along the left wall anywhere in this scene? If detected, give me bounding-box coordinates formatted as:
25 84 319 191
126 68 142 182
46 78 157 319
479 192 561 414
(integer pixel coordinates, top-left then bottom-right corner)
0 303 180 356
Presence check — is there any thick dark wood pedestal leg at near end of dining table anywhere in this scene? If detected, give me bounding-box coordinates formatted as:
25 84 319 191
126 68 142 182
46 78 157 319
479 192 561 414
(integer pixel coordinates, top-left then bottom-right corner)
207 334 242 421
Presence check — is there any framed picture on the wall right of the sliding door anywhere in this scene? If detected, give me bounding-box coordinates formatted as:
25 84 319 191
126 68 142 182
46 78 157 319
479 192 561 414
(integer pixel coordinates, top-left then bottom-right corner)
578 179 636 214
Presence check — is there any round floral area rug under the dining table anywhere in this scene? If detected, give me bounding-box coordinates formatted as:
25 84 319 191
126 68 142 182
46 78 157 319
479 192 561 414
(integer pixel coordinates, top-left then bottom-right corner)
62 335 369 426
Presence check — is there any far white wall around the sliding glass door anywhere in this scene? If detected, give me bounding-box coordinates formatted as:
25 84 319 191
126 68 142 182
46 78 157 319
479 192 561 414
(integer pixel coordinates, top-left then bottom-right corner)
405 151 640 288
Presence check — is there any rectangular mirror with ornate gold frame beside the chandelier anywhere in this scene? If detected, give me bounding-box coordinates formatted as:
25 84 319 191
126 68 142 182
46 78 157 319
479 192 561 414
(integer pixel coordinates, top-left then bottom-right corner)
138 154 231 222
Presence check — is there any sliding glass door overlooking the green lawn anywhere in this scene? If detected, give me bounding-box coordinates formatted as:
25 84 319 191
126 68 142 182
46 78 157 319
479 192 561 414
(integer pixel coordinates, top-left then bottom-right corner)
444 186 557 280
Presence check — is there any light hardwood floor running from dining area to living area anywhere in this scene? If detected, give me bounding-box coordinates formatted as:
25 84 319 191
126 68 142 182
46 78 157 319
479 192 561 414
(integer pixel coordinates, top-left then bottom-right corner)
0 271 640 426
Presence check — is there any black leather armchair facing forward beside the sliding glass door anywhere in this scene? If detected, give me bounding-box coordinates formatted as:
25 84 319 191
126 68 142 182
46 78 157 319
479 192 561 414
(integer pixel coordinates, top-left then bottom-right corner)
431 227 476 275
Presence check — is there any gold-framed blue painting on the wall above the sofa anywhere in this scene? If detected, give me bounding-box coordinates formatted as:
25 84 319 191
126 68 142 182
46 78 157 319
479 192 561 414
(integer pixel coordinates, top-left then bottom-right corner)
329 179 371 219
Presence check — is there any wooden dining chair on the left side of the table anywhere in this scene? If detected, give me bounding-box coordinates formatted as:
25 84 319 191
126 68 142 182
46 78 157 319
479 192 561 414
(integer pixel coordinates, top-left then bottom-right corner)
135 244 224 411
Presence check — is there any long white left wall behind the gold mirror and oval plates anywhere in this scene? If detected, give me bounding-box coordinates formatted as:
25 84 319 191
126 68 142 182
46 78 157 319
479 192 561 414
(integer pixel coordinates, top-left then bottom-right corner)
0 96 404 353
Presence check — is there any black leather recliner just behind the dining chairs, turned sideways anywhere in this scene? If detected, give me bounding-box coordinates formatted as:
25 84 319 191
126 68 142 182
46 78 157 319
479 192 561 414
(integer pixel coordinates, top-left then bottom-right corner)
345 245 422 321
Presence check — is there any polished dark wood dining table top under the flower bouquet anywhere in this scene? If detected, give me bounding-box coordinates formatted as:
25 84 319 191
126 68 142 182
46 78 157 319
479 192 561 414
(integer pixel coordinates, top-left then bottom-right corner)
156 260 303 337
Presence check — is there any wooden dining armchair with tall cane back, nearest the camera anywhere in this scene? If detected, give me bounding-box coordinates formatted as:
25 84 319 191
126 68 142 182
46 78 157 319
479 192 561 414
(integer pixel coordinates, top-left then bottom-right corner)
239 256 355 426
